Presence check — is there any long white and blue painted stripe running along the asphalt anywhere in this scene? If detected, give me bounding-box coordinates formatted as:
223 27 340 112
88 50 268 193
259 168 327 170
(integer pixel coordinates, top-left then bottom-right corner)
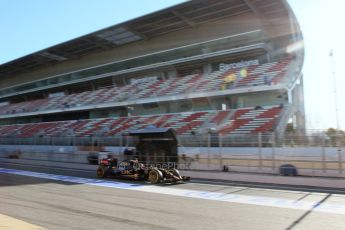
0 168 345 215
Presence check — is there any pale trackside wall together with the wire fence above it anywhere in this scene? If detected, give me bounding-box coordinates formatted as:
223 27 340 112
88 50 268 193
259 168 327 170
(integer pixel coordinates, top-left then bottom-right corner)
0 133 345 177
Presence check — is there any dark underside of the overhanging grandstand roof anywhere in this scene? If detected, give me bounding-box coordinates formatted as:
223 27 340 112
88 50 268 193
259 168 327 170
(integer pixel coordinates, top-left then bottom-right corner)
0 0 287 77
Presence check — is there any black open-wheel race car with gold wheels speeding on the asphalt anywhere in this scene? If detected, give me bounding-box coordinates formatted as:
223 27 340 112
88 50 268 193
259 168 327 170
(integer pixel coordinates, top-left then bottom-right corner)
97 158 190 184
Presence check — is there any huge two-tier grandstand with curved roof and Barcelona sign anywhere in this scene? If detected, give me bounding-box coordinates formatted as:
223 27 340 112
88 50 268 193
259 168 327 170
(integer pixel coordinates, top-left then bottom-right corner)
0 0 304 148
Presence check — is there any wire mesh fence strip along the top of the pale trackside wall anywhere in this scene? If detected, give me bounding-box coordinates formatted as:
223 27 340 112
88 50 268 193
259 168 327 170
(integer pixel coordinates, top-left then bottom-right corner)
0 133 345 147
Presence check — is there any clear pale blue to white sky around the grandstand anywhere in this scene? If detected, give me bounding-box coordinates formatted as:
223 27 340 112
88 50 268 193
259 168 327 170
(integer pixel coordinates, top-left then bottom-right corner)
0 0 345 129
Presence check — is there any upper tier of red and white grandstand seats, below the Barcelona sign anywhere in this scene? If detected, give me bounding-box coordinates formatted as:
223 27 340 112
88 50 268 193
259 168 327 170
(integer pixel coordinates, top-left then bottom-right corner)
0 59 291 115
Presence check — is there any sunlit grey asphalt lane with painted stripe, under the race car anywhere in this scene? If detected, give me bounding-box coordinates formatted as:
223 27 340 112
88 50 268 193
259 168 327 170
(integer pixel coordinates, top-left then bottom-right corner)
0 165 345 229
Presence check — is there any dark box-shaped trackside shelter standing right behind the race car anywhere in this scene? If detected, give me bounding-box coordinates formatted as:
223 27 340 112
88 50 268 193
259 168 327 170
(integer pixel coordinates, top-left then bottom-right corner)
125 128 178 164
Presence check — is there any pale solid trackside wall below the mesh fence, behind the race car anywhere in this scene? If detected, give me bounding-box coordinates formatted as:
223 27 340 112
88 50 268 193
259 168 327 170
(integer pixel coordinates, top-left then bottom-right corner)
0 145 345 177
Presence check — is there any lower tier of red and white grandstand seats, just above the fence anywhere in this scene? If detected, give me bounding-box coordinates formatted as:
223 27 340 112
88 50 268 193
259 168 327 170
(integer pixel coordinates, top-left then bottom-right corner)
0 106 283 138
